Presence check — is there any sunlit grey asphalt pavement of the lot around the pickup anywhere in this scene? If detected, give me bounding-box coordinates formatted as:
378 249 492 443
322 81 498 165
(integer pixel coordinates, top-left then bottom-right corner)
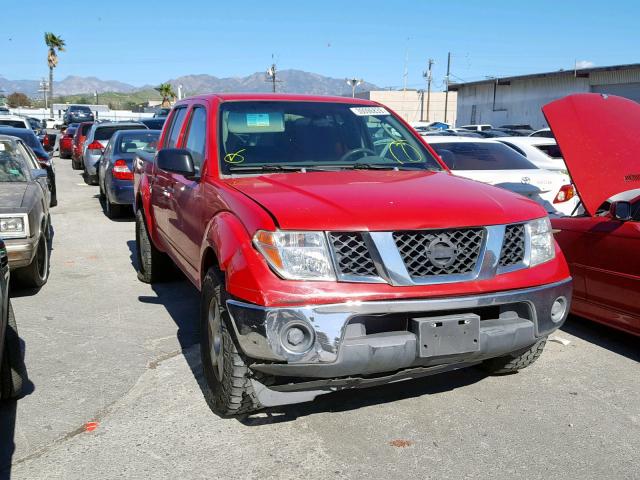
0 154 640 480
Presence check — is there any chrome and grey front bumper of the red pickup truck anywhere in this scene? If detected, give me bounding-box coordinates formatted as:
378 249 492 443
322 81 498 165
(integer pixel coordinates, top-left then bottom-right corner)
227 278 572 379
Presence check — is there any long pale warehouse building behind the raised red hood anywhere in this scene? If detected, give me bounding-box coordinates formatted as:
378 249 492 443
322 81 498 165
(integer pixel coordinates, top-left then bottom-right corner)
449 63 640 128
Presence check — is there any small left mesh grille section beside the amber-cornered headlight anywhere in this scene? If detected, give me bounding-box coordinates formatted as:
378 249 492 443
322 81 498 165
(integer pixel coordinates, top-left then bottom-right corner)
329 232 378 277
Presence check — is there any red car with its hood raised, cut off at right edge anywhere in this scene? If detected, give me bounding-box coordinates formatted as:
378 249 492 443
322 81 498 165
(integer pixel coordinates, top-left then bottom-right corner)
543 93 640 335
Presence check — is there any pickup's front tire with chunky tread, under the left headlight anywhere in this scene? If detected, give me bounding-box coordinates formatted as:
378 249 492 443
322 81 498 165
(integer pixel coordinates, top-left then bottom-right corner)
200 268 262 417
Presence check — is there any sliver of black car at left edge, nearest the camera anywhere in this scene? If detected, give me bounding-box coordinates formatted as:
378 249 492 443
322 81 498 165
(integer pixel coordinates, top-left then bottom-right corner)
0 239 25 400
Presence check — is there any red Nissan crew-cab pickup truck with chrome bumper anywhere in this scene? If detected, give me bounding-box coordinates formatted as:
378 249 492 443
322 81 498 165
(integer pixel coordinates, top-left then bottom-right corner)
135 94 572 415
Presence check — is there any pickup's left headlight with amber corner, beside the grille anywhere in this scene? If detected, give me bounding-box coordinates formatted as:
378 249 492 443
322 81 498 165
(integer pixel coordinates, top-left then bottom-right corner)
253 230 336 280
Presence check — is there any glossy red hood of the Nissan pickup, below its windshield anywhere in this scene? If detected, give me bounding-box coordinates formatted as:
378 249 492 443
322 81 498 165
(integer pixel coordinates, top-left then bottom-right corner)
228 170 545 231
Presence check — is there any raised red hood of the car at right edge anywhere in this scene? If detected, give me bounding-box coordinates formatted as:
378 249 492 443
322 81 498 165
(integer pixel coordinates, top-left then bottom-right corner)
542 93 640 215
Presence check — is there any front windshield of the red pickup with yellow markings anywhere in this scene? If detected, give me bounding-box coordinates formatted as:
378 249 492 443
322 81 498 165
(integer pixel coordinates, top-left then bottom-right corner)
220 101 442 174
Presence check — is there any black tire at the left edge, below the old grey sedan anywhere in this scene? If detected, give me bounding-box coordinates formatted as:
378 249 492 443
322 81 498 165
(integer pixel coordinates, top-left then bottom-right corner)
0 302 26 400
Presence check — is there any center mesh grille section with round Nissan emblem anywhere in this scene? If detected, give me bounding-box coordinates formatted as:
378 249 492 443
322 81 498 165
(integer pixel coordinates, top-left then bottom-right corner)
393 228 484 277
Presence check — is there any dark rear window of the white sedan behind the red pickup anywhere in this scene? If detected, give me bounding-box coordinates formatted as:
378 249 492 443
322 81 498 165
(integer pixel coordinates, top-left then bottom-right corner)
431 142 538 170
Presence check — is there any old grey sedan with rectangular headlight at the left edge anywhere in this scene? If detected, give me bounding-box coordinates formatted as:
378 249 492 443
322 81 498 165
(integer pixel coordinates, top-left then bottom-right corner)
0 135 51 288
